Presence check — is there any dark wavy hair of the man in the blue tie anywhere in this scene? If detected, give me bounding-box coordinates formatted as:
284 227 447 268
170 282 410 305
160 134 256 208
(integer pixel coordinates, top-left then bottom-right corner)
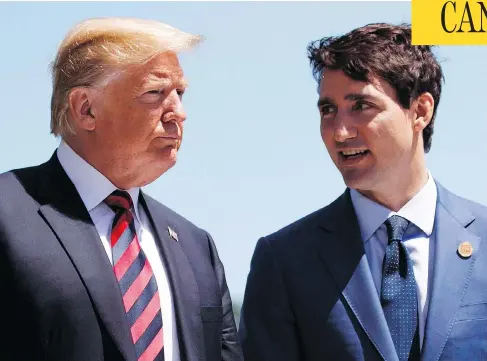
307 23 444 153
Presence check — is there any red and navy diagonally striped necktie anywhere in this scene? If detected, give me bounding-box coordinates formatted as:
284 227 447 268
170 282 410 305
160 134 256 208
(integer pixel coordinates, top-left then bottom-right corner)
105 190 164 361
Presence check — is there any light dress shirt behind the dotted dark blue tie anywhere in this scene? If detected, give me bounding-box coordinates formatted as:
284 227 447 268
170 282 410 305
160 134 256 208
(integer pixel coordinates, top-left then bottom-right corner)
350 172 437 347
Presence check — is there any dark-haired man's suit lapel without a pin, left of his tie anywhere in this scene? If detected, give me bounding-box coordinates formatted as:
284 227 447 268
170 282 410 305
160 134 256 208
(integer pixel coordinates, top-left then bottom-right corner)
319 189 398 361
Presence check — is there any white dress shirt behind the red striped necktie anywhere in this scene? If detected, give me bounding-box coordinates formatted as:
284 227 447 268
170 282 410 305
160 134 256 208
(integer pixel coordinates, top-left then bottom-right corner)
57 141 180 361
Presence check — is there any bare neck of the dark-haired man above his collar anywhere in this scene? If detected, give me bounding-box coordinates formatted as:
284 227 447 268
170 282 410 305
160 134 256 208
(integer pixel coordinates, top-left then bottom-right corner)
359 158 428 212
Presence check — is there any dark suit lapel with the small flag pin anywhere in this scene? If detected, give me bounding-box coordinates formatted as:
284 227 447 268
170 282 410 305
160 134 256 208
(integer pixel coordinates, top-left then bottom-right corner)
141 192 204 361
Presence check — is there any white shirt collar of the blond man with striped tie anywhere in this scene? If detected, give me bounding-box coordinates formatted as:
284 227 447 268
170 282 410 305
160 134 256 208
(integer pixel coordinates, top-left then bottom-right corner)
57 140 140 220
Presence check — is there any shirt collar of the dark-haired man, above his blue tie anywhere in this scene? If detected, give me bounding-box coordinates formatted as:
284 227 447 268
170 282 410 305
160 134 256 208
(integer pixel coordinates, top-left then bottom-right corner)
350 171 437 242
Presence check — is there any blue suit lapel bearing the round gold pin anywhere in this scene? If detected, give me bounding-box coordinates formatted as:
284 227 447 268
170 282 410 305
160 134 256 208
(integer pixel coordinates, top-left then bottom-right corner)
422 184 481 361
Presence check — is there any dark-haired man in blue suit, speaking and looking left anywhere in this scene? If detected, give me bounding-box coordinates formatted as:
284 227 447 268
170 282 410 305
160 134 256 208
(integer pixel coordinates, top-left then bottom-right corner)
239 24 487 361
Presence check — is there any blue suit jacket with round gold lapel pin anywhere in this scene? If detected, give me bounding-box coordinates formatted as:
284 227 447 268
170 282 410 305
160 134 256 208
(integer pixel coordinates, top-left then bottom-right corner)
239 183 487 361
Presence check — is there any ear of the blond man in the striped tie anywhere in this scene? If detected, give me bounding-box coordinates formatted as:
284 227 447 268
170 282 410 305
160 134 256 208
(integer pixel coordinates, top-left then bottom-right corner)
68 88 96 131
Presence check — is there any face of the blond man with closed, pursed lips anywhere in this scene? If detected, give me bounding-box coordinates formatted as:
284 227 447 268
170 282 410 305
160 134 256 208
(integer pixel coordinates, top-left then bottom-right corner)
93 53 186 186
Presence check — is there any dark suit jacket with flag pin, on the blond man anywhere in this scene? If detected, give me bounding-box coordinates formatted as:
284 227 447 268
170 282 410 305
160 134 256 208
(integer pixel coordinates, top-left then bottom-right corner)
0 155 243 361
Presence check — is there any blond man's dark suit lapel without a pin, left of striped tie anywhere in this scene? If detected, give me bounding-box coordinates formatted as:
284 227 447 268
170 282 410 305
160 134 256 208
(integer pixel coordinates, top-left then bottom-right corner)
39 155 135 361
